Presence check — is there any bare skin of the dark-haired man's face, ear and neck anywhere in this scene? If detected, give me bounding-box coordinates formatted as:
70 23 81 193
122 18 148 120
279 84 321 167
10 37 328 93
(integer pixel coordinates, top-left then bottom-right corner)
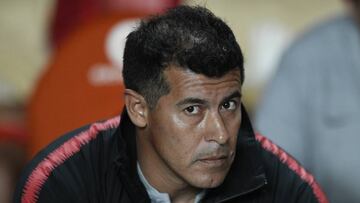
125 67 241 202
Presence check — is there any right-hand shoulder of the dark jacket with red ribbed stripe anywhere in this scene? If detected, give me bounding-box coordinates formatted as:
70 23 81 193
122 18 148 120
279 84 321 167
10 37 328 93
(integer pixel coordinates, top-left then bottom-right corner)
256 134 328 203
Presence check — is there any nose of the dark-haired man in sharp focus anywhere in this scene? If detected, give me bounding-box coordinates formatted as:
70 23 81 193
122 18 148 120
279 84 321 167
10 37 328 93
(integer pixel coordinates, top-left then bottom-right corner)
205 112 230 145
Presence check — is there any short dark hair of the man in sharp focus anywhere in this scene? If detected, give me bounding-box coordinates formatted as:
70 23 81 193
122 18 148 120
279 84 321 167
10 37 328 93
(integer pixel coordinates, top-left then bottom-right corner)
123 6 244 108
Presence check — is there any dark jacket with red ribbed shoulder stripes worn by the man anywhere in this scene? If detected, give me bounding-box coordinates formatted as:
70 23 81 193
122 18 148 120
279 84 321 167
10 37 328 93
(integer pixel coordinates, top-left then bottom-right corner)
14 107 327 203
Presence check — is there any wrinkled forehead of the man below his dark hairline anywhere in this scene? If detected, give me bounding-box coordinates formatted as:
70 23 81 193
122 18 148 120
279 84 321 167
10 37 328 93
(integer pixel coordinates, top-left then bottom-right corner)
164 67 241 95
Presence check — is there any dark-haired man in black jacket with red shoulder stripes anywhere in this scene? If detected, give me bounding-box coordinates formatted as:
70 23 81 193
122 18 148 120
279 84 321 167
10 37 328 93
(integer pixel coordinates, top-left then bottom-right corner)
15 6 326 203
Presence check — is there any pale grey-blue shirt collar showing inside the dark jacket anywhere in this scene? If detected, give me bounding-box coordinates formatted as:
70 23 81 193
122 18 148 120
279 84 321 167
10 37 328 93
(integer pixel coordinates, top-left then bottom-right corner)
137 162 205 203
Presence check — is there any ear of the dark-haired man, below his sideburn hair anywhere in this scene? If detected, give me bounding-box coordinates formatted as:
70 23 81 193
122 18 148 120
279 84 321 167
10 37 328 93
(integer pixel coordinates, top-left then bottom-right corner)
125 89 148 128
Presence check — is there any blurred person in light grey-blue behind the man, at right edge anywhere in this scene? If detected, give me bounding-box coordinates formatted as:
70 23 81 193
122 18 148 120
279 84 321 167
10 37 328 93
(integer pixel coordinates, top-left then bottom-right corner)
256 0 360 202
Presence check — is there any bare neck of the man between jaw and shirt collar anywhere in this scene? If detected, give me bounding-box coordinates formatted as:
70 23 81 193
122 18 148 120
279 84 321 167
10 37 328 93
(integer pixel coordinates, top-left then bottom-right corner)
136 129 201 203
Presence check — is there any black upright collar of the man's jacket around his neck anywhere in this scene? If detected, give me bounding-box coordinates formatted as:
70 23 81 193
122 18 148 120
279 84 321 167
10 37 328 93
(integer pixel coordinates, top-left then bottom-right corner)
116 106 266 202
